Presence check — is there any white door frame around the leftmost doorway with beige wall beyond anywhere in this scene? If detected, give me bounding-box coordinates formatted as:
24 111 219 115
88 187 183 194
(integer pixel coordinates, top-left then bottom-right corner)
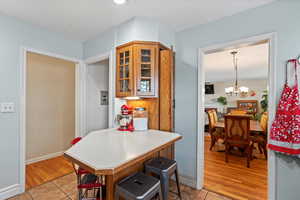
19 46 84 193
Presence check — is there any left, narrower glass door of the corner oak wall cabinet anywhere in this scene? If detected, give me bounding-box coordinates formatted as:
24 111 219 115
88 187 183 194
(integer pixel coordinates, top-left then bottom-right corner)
117 48 132 97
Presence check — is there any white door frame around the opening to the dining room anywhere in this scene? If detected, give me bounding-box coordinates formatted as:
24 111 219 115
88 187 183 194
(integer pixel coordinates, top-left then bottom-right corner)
196 32 277 200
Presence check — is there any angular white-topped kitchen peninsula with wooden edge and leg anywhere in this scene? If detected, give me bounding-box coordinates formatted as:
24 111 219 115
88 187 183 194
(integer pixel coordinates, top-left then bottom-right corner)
64 129 182 200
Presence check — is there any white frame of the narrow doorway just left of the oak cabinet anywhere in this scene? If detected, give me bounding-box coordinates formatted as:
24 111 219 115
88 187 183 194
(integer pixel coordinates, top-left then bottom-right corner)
82 51 116 130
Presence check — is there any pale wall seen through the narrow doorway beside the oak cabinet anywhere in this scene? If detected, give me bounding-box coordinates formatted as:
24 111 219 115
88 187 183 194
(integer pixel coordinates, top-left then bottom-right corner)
86 59 109 133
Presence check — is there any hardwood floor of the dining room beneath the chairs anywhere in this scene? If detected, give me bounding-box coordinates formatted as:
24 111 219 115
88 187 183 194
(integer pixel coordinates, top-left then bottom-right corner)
204 136 268 200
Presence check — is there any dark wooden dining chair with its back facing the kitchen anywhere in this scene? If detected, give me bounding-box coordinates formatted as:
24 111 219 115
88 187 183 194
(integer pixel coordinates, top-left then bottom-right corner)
224 115 253 167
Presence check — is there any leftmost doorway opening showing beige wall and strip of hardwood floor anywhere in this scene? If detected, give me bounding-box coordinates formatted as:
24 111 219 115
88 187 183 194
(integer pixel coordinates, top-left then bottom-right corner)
25 52 76 190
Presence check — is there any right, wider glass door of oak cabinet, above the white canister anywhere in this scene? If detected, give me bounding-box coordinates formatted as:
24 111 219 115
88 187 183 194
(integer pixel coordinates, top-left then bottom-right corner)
136 45 155 96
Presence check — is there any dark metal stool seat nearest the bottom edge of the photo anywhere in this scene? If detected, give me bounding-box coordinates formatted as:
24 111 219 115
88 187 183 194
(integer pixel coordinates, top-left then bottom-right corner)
116 172 161 200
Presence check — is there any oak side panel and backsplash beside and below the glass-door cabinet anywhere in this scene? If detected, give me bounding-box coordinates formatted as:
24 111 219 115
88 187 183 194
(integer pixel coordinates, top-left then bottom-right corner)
127 49 174 159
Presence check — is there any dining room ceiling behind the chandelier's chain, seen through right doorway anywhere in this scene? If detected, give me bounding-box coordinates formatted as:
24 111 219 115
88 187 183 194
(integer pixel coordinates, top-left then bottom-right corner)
204 43 269 82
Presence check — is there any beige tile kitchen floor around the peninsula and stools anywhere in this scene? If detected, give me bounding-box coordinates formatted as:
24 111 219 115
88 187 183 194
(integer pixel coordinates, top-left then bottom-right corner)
9 173 229 200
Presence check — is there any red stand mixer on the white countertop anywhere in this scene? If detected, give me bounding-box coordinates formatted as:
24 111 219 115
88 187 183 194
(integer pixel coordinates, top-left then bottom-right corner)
117 105 134 131
